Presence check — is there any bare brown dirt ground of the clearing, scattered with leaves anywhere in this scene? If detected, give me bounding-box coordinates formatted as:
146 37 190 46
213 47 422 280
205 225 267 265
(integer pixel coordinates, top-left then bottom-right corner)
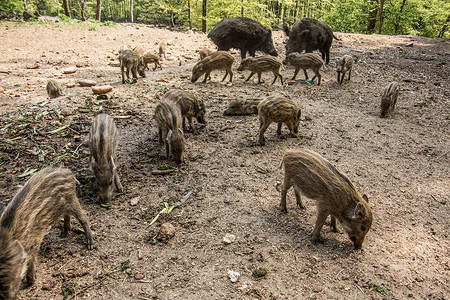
0 22 450 299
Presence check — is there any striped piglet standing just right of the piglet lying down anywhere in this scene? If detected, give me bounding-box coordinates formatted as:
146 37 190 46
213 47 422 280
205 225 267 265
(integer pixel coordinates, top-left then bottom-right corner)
258 96 302 145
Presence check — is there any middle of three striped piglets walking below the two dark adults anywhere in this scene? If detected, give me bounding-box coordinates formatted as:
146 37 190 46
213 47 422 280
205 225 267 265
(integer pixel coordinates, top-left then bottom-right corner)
238 56 283 85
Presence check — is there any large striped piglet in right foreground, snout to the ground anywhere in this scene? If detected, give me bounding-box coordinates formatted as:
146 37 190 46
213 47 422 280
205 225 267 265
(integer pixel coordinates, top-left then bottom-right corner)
280 149 372 249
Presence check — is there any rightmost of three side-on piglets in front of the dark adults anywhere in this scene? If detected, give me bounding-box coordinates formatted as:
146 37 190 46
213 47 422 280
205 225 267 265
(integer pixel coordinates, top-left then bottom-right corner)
284 53 323 85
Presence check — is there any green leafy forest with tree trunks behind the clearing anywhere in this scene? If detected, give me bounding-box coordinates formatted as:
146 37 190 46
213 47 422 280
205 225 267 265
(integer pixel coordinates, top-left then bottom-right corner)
0 0 450 38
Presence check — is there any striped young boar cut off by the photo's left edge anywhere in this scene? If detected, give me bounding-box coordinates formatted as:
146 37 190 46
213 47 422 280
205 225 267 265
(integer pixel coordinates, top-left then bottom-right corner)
0 168 94 299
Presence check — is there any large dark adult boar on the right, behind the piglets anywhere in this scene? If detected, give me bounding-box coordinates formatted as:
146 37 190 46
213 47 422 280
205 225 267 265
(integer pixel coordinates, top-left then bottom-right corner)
283 18 337 64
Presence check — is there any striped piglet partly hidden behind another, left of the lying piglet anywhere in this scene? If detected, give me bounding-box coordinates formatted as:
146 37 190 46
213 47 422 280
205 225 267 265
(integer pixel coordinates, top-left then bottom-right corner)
161 89 206 133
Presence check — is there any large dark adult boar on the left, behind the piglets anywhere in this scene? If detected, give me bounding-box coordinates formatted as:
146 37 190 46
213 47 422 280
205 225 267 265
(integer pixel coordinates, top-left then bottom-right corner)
208 17 278 59
